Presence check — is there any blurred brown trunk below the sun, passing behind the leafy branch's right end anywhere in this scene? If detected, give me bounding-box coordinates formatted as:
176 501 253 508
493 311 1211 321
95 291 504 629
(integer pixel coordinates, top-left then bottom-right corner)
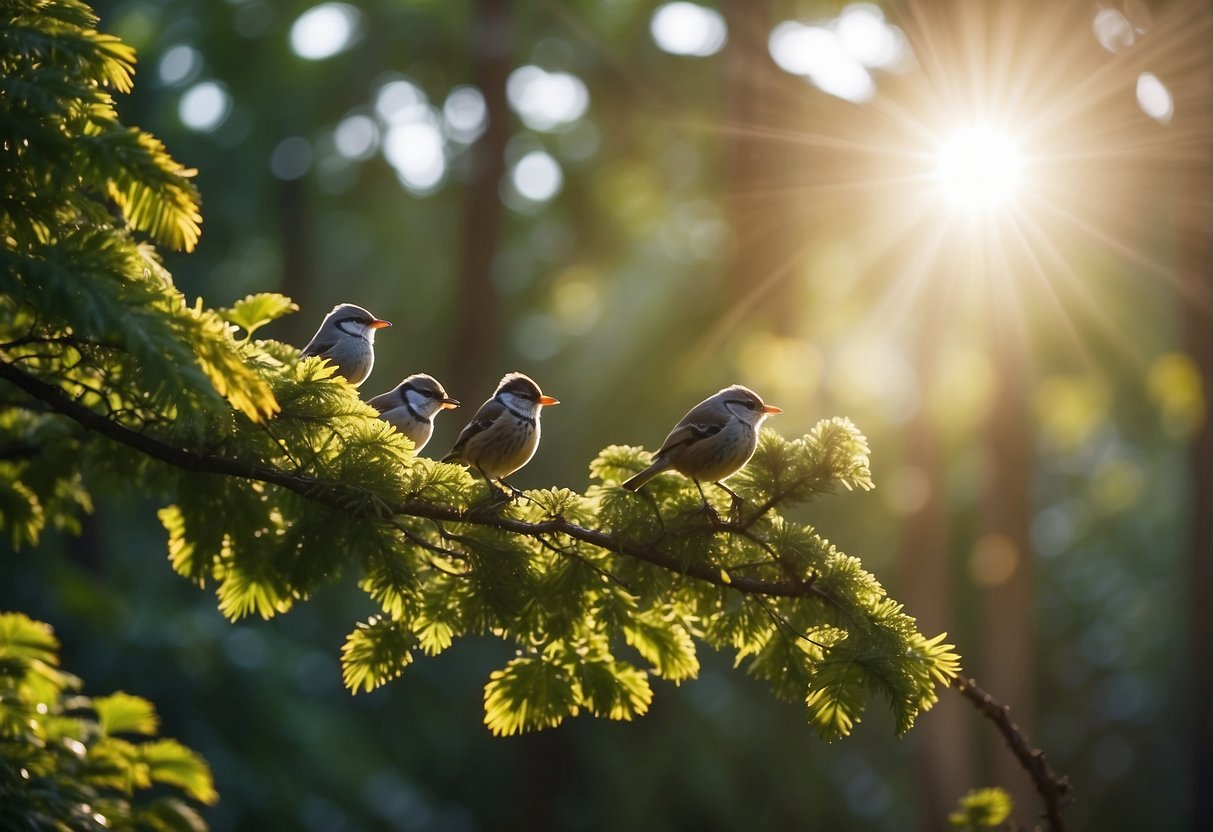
898 304 973 830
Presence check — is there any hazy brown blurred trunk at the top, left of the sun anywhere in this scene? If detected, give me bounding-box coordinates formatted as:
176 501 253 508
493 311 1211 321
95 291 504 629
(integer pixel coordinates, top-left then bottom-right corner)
721 0 795 335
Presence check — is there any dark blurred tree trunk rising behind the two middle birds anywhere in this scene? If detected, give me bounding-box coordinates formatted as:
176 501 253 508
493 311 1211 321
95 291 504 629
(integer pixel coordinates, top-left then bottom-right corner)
443 0 513 391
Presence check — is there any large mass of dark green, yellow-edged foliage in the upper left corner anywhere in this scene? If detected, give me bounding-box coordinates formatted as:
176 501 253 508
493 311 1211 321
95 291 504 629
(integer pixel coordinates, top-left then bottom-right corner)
0 0 277 434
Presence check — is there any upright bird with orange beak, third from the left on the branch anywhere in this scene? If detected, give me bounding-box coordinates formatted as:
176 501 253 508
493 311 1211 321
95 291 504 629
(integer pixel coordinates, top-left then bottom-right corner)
442 372 560 495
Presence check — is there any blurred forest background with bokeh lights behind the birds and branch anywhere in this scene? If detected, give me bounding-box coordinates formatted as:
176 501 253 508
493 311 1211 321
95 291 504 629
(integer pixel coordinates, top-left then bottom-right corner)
0 0 1213 832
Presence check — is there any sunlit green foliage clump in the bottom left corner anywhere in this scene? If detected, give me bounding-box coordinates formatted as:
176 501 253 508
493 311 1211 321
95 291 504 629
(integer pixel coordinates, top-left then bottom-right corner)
0 612 218 831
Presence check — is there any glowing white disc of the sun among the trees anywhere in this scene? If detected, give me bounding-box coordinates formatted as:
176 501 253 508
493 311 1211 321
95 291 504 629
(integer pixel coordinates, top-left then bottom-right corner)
935 124 1023 212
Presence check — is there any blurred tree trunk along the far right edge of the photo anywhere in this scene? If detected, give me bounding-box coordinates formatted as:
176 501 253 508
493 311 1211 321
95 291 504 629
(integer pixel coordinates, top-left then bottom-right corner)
1172 0 1213 831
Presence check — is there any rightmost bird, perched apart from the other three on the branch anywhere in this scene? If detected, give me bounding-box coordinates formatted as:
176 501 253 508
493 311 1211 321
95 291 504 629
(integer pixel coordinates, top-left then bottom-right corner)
622 384 784 514
